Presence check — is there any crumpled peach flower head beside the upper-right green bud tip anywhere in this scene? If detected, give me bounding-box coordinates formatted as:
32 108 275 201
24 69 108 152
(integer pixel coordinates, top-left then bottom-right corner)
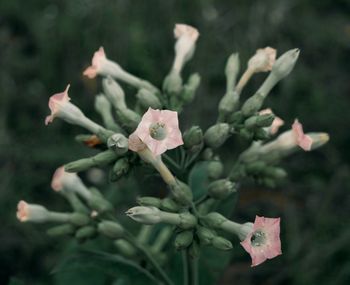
248 47 276 72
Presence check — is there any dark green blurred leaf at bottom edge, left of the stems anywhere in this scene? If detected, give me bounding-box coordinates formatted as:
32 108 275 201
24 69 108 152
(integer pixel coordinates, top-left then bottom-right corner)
52 250 160 285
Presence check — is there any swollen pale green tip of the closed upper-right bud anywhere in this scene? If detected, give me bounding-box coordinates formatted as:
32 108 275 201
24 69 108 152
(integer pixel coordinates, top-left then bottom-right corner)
271 48 300 80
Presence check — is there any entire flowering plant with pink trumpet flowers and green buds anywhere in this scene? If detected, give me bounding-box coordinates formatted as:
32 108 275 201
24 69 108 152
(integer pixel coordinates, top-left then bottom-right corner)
17 24 328 285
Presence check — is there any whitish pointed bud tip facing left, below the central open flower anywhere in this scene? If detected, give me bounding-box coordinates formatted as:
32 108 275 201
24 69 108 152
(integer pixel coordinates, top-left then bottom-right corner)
125 206 162 225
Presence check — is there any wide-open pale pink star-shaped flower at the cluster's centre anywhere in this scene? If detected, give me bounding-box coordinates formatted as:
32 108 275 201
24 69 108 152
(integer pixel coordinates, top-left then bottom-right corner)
129 108 183 155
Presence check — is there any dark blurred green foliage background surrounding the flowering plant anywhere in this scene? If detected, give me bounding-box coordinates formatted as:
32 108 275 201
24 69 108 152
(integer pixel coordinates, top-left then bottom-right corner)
0 0 350 285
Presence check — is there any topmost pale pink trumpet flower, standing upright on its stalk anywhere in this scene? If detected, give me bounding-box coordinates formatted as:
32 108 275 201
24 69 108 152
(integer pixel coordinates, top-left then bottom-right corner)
173 24 199 72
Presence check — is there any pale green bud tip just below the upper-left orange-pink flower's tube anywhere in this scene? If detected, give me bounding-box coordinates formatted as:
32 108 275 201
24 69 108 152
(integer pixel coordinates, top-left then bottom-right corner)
102 77 127 109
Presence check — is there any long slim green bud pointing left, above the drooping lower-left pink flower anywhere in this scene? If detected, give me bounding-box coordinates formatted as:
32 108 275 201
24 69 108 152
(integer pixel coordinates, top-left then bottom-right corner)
64 149 118 172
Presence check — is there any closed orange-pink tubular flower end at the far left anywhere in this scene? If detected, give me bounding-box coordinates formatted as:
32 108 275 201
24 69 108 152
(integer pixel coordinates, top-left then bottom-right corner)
17 201 49 222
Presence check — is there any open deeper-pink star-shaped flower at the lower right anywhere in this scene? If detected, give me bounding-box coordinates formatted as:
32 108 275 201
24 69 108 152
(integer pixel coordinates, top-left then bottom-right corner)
241 216 282 266
